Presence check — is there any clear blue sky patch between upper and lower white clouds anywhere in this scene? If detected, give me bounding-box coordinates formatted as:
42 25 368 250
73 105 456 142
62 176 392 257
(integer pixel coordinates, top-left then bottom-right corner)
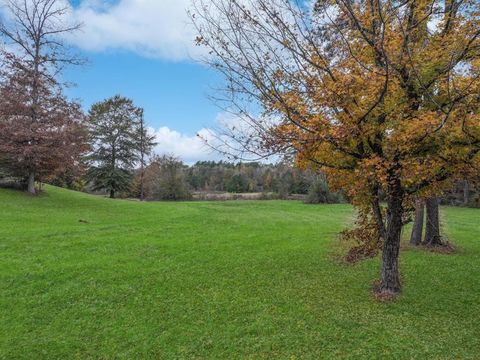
65 50 221 134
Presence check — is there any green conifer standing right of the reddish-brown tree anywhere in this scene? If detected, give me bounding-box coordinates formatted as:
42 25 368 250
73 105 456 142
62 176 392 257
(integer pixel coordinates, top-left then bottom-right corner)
87 95 142 198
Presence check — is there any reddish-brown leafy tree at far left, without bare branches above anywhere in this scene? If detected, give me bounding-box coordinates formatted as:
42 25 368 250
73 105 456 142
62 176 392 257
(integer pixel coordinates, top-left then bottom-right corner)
0 71 88 190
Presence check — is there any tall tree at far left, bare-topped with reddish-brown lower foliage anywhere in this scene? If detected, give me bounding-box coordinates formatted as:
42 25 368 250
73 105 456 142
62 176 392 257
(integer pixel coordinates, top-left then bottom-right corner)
0 0 85 194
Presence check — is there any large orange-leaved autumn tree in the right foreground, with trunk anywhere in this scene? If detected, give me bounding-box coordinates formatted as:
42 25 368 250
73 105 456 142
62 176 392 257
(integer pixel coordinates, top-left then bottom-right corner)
192 0 480 295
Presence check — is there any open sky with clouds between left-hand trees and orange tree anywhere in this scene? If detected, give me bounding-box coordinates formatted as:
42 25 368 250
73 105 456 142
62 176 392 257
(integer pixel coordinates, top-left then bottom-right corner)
65 0 227 163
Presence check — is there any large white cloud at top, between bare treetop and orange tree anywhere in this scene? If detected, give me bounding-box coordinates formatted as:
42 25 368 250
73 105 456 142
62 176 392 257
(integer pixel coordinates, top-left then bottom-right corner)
70 0 204 60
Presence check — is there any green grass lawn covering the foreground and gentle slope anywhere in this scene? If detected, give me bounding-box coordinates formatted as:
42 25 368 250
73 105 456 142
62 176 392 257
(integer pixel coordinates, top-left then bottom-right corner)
0 187 480 359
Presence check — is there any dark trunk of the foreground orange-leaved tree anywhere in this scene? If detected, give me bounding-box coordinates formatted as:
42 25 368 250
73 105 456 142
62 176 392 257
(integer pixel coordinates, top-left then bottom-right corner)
378 171 403 295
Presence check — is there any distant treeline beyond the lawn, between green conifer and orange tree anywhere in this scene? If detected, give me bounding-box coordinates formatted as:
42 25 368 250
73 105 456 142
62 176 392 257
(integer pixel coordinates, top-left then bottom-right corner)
120 156 346 203
